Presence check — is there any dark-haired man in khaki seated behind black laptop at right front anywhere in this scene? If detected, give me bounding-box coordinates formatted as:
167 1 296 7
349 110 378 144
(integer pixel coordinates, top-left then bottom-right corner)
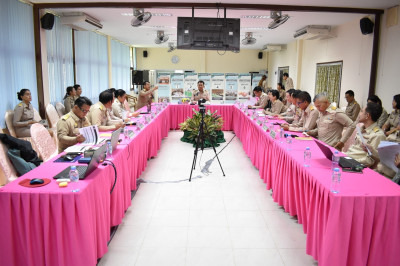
346 102 386 168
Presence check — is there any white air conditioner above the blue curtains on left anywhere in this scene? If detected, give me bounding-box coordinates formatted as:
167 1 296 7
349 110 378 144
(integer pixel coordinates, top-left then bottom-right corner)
61 12 103 31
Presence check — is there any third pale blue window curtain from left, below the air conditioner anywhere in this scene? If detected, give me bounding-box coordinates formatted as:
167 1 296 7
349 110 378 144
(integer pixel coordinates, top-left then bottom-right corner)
75 31 109 103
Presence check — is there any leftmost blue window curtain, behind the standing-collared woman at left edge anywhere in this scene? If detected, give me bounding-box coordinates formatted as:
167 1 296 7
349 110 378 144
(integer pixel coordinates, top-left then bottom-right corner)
0 0 38 128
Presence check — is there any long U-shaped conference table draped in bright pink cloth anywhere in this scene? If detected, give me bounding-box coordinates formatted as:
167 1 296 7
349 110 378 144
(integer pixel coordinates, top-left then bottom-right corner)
0 104 400 265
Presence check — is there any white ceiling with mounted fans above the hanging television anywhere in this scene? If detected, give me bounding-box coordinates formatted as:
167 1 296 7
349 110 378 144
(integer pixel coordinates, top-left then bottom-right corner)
31 0 399 49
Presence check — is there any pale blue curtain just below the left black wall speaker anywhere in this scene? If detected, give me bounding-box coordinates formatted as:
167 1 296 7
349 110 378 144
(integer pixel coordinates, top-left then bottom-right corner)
46 17 74 105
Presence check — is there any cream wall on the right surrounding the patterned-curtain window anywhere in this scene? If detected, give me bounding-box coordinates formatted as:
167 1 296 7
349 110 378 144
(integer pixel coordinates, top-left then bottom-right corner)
268 15 373 106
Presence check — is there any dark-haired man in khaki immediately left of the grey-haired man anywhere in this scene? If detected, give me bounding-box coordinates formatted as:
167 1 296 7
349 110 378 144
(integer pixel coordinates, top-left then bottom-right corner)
282 91 319 132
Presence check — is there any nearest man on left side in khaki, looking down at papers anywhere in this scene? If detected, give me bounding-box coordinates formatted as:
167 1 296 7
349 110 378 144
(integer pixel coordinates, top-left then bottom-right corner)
57 97 92 153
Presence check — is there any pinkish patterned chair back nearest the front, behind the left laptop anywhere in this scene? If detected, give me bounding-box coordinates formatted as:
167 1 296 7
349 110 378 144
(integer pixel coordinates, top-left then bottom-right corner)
31 123 57 161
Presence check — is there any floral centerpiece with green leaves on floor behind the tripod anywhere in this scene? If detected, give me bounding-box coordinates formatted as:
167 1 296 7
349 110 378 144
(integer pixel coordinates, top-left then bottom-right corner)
179 109 225 147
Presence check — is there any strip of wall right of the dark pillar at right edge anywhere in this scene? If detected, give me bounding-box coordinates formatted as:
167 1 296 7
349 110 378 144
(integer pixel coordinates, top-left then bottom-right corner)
376 7 400 112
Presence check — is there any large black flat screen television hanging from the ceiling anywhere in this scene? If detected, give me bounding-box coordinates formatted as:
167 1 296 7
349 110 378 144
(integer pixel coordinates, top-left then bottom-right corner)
177 17 240 51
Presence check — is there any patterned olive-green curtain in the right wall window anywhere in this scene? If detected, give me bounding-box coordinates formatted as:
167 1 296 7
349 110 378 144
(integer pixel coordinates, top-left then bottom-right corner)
315 63 342 105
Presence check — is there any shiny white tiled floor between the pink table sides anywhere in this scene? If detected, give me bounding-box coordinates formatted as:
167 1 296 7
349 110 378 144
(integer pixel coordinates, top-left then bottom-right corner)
99 131 317 266
